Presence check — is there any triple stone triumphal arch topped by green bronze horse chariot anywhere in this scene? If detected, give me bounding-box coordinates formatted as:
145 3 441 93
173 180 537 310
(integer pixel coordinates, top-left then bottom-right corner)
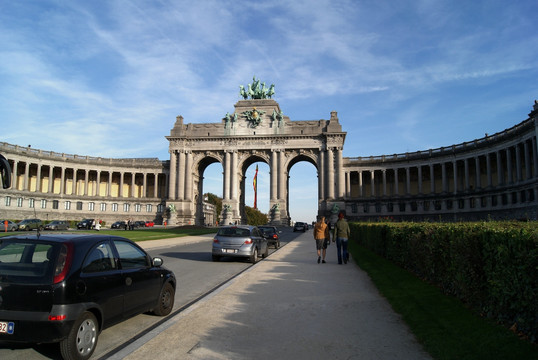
166 78 346 225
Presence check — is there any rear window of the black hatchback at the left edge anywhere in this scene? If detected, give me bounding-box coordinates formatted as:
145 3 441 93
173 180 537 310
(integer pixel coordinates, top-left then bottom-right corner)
0 241 55 284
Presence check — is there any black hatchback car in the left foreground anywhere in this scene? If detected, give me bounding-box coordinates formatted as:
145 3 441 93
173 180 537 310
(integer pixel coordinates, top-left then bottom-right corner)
0 234 176 359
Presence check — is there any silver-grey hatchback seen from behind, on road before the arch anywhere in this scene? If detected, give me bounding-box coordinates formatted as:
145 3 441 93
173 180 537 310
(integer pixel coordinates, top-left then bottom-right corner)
212 225 269 264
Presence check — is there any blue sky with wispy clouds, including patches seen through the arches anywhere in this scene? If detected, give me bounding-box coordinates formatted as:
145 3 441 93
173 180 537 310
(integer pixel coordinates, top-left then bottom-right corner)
0 0 538 221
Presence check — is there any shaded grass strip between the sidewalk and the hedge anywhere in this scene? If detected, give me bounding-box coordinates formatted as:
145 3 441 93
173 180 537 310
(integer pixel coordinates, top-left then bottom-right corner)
349 241 538 360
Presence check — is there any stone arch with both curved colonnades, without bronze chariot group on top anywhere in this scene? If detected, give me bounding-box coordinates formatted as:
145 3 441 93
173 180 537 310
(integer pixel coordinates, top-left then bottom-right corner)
0 99 538 225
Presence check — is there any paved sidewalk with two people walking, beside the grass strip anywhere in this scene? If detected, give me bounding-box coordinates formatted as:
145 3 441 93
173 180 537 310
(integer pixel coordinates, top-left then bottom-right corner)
112 232 431 360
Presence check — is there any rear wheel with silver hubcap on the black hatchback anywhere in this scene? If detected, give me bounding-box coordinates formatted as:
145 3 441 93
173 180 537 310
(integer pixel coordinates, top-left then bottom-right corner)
60 311 98 360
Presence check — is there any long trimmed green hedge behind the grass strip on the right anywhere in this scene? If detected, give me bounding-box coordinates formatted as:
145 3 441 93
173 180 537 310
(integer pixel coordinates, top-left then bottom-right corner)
350 222 538 342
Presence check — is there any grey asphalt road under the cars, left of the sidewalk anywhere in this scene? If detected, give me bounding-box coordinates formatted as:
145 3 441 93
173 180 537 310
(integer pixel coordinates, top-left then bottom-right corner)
0 229 296 360
